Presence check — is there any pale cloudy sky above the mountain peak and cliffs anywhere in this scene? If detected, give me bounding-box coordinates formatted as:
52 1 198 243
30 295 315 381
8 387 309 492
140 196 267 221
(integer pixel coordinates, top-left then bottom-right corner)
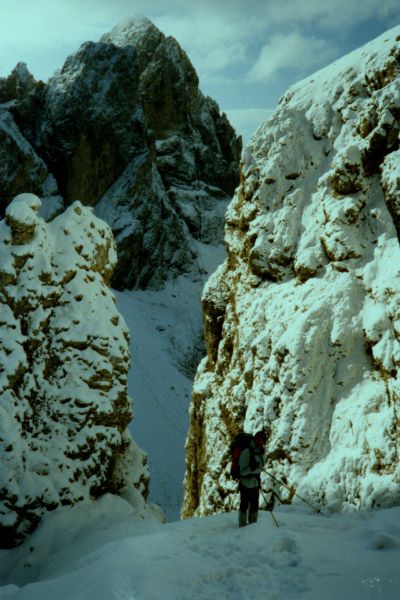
0 0 400 139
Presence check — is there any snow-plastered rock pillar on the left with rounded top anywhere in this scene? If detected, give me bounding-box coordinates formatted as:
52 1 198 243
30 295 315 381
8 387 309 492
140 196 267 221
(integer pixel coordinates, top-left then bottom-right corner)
0 194 148 547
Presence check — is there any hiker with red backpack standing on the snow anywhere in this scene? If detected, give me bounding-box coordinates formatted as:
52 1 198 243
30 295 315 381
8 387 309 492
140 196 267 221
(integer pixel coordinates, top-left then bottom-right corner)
239 430 267 527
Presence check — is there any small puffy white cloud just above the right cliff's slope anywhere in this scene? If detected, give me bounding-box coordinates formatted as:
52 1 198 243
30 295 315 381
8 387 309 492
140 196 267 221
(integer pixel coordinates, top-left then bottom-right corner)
248 32 334 81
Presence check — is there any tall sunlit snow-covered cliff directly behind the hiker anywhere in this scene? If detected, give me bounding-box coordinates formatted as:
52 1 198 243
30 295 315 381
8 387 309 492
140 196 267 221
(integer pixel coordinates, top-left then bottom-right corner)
183 28 400 516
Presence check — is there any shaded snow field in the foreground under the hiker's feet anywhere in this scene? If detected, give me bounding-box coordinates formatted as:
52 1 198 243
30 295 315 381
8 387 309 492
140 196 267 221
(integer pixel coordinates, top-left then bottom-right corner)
0 495 400 600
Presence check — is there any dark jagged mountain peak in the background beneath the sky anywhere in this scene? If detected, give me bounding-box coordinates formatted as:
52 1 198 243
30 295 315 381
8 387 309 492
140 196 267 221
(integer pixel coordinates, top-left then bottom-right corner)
0 19 241 288
